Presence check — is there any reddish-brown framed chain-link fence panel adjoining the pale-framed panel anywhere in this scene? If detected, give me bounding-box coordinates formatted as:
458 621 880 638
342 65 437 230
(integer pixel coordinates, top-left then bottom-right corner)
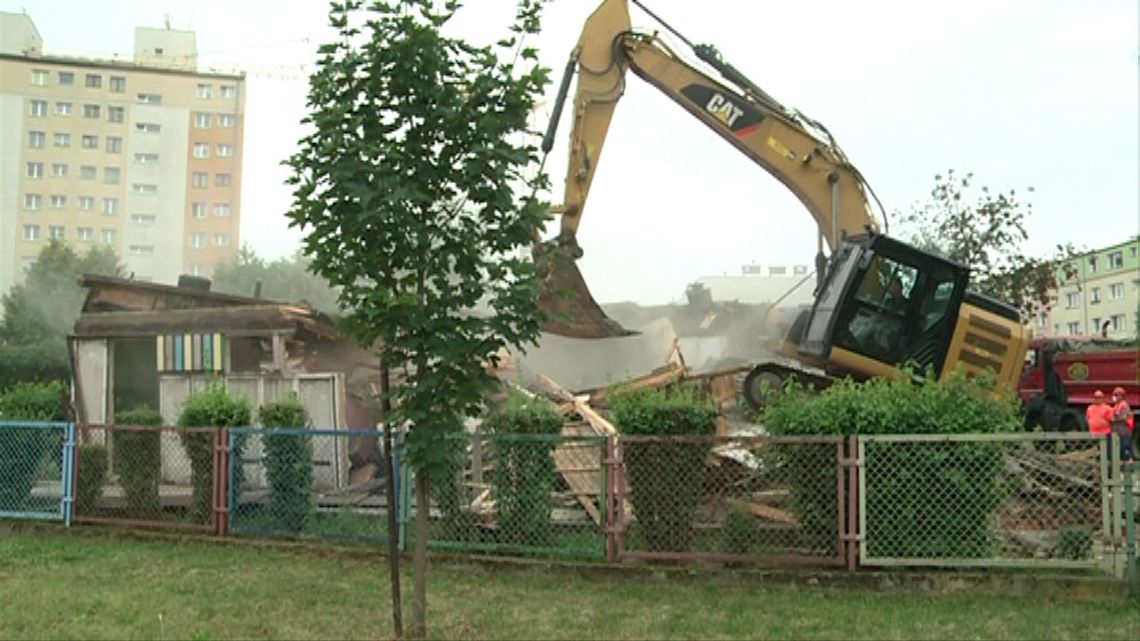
613 436 848 565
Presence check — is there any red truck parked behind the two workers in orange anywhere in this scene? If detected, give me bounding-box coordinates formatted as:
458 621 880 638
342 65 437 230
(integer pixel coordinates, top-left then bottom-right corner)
1018 338 1140 431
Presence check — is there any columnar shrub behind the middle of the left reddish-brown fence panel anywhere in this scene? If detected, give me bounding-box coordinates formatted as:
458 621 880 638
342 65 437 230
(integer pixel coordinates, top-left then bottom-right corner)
111 405 162 518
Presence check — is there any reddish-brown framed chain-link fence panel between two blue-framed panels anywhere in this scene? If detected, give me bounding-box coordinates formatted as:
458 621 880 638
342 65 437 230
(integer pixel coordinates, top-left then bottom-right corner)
74 425 226 534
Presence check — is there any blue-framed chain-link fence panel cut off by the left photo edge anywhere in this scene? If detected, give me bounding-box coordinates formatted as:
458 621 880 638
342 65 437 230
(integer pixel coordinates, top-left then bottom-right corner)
0 421 75 522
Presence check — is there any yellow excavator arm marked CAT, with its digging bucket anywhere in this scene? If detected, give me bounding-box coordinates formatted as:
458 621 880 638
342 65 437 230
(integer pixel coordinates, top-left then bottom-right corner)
536 0 879 338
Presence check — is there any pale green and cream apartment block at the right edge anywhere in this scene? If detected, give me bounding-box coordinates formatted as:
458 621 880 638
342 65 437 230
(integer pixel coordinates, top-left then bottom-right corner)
1033 236 1140 339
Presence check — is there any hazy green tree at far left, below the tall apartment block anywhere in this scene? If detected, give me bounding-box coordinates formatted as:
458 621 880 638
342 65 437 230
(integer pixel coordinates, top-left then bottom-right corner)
0 240 122 389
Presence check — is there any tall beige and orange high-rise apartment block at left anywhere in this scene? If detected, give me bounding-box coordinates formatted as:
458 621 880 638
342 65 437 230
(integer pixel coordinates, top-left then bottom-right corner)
0 13 245 292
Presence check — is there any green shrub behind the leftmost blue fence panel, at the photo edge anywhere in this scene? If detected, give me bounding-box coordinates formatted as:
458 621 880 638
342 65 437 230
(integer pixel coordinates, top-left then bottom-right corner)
0 381 66 511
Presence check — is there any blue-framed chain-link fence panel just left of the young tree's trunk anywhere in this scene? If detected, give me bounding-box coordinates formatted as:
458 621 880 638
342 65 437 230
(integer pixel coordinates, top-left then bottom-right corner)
228 428 400 541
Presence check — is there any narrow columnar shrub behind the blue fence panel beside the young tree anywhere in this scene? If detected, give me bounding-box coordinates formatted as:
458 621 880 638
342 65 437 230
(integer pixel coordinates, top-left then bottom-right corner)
259 393 314 533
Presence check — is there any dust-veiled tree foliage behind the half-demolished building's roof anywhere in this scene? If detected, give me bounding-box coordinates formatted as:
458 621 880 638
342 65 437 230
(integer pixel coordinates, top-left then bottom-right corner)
212 245 340 314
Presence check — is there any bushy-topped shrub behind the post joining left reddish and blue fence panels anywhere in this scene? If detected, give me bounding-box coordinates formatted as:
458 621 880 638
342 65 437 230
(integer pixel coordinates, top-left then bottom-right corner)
177 381 253 522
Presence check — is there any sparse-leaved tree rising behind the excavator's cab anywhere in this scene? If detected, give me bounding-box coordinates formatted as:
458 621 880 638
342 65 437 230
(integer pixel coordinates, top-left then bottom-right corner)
902 170 1077 317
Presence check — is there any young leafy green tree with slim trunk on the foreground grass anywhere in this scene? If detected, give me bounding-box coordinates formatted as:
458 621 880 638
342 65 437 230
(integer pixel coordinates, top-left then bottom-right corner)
287 0 548 635
